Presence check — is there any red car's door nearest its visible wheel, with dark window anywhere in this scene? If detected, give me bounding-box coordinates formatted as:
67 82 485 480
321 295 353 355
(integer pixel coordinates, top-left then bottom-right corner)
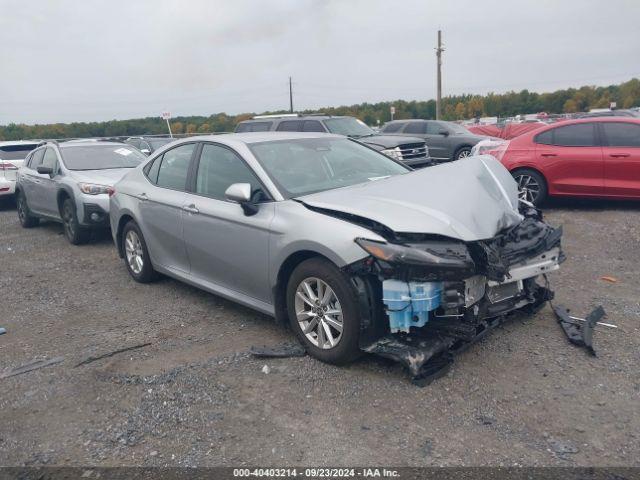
534 122 604 196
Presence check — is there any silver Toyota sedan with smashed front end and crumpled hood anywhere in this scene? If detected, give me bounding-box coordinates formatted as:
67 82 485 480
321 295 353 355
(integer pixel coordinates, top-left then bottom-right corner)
110 133 564 378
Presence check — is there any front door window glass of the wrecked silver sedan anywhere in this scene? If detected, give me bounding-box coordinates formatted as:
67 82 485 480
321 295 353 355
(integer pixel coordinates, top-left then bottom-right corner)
196 143 262 200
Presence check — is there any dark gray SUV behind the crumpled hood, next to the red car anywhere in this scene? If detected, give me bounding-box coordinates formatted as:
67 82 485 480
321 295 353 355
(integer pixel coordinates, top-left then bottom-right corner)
381 120 488 162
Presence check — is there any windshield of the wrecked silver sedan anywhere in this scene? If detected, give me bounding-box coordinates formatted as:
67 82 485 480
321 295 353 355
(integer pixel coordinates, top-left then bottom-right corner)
249 138 409 198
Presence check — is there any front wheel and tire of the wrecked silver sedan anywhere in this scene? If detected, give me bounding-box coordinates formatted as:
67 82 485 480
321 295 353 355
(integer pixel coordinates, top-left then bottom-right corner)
287 258 360 365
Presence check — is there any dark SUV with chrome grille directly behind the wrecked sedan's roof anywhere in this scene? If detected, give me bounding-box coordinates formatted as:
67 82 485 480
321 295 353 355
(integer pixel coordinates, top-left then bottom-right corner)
235 113 432 167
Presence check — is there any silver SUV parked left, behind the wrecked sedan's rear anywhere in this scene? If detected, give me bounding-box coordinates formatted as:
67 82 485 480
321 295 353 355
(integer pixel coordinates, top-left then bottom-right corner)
16 140 147 245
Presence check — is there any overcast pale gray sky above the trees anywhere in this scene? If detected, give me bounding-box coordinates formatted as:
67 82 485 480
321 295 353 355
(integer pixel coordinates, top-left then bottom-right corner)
0 0 640 125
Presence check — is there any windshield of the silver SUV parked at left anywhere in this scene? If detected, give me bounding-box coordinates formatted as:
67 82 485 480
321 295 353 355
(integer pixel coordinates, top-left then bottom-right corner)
60 144 147 170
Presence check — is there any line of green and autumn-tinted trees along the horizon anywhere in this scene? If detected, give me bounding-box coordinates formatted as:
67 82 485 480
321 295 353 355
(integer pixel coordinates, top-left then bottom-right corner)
0 78 640 140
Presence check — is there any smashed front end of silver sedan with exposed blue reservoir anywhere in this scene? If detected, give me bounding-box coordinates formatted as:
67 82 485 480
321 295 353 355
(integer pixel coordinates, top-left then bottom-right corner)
350 211 564 384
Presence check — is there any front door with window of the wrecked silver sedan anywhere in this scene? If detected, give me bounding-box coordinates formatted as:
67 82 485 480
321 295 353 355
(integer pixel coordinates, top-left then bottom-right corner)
182 143 275 303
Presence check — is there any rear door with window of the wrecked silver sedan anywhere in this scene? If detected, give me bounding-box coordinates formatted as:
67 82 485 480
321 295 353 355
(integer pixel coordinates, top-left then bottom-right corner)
134 143 197 273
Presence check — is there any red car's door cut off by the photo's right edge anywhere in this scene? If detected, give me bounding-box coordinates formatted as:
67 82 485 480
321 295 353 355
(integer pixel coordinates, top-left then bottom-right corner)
600 122 640 198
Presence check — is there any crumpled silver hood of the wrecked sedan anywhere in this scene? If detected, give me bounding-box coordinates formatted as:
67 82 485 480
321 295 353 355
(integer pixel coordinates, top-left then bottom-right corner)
298 155 523 242
